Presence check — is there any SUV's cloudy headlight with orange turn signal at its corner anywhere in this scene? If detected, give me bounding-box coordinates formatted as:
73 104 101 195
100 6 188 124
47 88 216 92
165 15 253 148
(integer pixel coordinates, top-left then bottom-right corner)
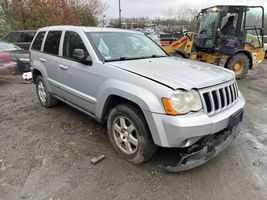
162 90 202 115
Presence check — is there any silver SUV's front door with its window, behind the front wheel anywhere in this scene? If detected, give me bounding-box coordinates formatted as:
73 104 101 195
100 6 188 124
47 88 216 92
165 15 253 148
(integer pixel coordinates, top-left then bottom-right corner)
58 31 96 114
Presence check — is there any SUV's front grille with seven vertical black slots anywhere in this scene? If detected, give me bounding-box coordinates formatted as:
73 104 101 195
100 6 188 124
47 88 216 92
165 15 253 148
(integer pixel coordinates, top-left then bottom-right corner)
199 82 238 115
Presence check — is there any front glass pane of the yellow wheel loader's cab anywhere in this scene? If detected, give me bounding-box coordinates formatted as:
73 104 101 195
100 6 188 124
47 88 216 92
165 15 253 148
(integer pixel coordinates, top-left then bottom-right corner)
198 11 219 36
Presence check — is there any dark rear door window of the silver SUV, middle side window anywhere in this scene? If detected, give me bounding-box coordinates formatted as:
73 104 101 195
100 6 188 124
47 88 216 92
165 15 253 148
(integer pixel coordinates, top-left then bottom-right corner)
44 31 62 55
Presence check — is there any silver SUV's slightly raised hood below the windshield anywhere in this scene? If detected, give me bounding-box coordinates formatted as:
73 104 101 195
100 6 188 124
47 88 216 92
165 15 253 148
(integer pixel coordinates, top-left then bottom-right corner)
109 57 235 90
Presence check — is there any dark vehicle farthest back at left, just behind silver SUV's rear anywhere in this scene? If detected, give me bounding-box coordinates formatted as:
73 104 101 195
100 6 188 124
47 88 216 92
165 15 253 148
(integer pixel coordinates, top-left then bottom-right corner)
3 30 36 50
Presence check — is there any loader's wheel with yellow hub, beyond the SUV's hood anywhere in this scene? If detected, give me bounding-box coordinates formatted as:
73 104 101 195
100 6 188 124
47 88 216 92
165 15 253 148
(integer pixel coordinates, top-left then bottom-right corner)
226 53 250 79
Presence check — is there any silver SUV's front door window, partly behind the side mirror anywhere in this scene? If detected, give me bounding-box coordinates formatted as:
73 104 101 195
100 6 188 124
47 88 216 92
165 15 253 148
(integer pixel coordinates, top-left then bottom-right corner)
63 31 89 60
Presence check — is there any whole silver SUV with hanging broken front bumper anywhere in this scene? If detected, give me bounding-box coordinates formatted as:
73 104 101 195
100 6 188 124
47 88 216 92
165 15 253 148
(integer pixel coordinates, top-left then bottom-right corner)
30 26 245 172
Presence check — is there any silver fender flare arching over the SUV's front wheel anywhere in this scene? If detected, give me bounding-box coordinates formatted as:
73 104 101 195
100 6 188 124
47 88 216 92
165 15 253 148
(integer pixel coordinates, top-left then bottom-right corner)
96 80 171 146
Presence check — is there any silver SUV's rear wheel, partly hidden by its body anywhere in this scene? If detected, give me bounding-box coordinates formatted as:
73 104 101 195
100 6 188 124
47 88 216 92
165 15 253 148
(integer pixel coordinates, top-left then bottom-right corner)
36 76 58 108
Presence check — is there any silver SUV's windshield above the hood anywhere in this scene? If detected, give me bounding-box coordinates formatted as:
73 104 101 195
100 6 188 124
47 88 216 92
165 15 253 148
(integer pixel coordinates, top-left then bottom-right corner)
86 32 167 61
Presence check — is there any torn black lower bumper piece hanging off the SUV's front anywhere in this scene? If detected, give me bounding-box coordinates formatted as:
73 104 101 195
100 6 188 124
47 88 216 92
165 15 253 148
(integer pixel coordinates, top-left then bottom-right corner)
161 109 243 173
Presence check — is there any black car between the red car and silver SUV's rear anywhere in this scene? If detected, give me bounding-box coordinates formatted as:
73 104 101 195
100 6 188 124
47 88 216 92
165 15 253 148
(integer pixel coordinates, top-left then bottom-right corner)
0 41 30 73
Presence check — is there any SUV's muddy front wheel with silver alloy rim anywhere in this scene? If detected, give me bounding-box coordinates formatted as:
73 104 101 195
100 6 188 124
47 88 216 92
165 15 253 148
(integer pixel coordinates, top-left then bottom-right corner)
107 104 157 164
